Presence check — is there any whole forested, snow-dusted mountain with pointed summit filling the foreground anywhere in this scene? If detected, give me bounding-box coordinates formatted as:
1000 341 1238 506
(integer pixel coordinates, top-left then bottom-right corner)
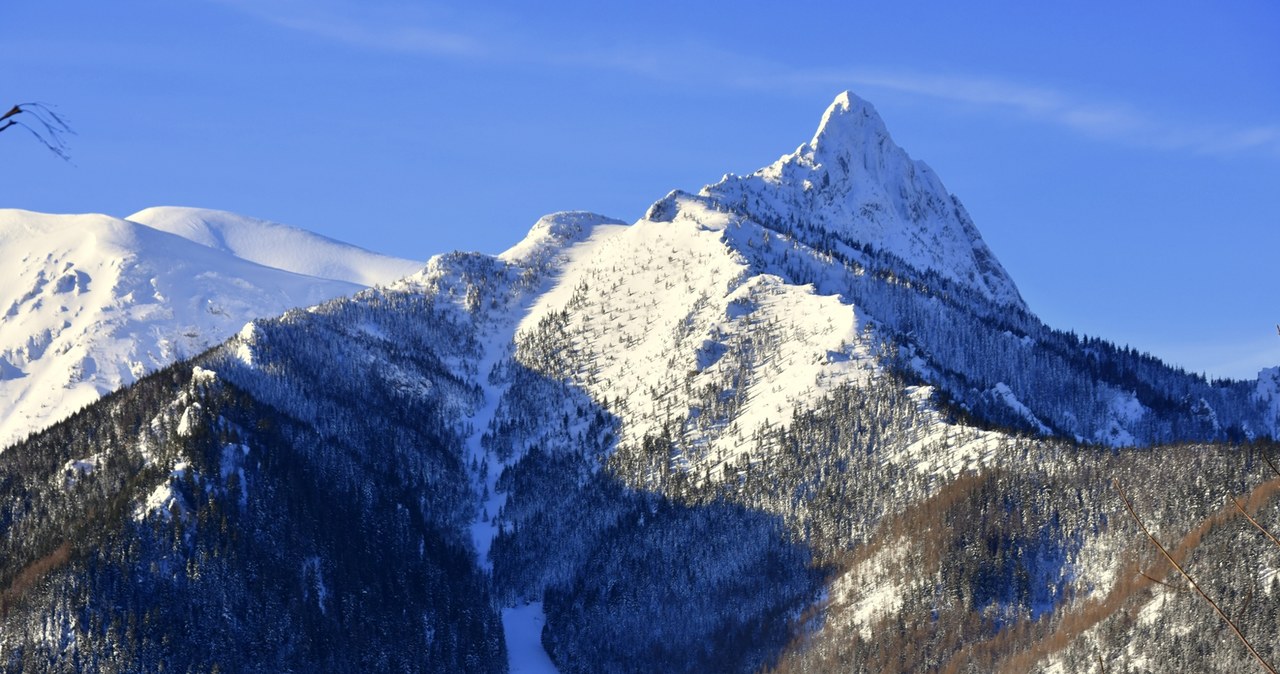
0 93 1280 673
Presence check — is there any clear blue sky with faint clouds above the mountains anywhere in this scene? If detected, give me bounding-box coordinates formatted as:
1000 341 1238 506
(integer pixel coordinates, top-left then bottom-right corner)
0 0 1280 376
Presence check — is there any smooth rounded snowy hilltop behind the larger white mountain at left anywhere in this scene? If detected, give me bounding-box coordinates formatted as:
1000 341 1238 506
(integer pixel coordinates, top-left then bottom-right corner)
127 206 422 285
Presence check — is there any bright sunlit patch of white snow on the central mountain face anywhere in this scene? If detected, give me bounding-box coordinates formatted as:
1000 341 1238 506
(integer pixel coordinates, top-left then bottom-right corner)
503 194 872 478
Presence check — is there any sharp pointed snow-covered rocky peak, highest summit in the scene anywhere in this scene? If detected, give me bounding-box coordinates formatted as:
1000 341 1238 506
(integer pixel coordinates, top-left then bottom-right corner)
700 92 1025 310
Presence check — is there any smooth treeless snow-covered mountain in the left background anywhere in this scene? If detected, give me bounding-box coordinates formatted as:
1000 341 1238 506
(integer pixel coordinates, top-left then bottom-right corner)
0 210 419 448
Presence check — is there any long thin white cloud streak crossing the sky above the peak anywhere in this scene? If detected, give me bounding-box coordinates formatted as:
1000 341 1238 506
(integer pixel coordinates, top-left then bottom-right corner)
212 0 1280 157
